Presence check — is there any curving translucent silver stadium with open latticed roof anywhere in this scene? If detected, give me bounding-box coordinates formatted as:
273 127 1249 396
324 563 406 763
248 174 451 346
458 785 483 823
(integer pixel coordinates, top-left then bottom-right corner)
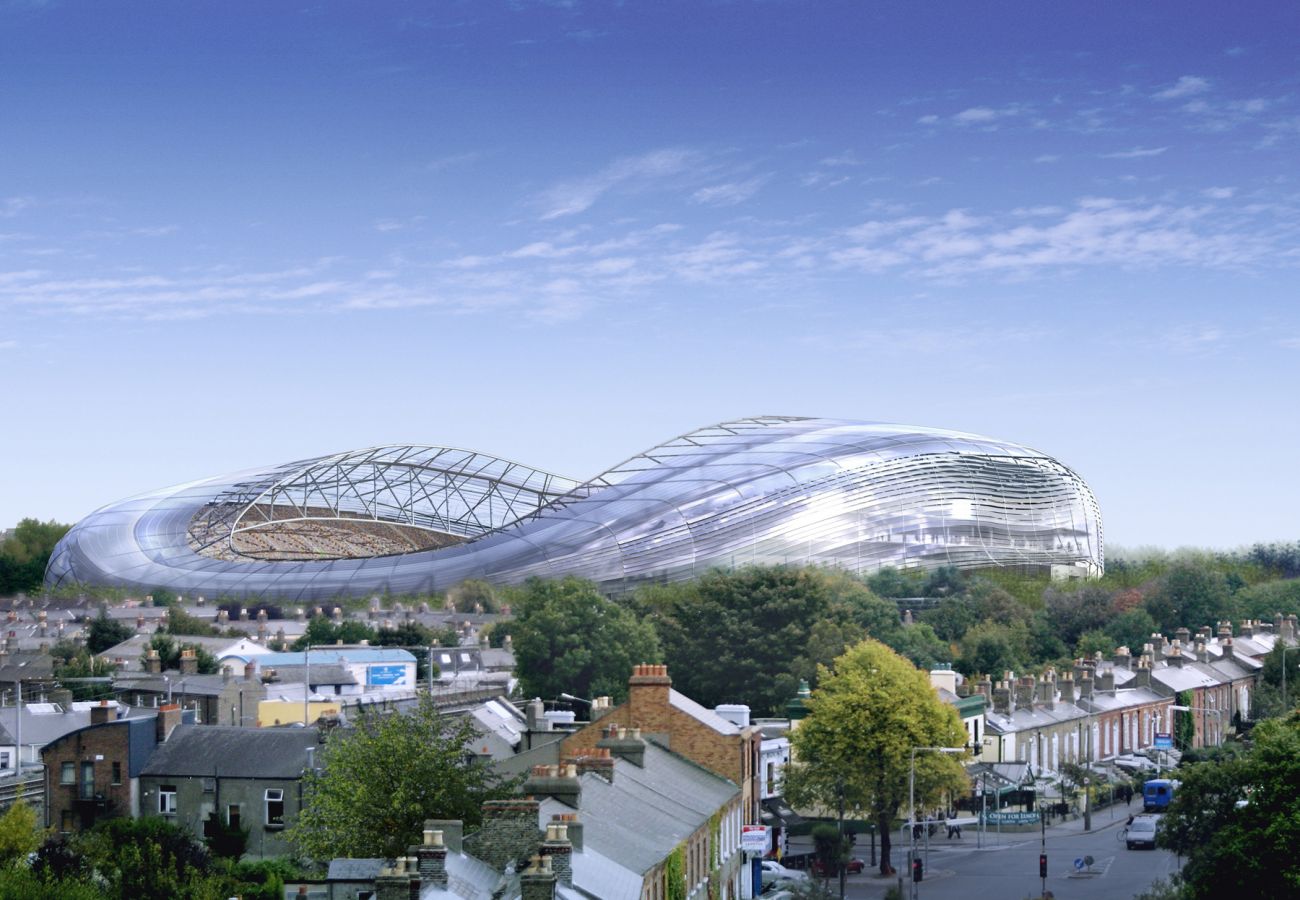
46 416 1104 601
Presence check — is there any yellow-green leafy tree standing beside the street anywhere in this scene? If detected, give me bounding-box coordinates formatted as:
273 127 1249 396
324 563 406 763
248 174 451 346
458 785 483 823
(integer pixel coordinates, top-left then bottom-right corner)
785 640 969 874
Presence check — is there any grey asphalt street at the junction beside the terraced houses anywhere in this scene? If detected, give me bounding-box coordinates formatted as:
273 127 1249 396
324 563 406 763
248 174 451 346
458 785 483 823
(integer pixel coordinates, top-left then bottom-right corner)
785 817 1178 900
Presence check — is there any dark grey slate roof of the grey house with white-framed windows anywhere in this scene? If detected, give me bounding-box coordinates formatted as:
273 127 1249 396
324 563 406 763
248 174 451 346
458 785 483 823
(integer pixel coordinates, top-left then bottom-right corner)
142 724 317 778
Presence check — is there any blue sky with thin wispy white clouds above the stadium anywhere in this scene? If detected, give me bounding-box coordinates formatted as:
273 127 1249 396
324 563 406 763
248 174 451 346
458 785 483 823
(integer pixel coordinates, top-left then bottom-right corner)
0 0 1300 548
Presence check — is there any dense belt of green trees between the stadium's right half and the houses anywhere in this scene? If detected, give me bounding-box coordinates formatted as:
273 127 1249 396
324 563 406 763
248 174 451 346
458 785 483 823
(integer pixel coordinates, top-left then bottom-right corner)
493 545 1300 715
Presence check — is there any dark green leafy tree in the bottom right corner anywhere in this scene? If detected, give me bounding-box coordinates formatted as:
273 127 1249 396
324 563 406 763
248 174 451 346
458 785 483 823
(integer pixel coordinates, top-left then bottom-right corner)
1157 715 1300 900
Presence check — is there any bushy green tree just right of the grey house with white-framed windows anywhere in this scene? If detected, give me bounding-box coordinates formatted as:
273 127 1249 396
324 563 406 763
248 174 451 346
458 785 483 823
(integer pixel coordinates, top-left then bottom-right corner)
287 696 512 861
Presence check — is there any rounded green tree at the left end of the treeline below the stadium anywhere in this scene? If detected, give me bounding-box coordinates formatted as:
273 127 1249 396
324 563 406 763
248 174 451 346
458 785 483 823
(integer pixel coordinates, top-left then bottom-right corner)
512 577 660 700
